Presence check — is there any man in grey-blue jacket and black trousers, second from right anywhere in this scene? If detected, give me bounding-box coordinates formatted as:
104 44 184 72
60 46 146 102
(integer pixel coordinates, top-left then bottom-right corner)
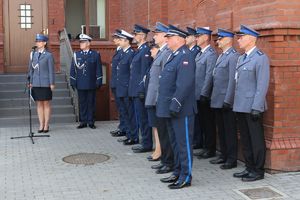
210 28 240 169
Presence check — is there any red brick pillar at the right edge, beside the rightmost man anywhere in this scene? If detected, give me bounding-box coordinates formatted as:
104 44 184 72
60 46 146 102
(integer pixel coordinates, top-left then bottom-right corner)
261 28 300 171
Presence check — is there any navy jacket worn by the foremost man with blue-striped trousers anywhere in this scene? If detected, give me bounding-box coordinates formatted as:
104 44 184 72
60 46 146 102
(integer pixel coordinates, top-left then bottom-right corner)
156 45 197 117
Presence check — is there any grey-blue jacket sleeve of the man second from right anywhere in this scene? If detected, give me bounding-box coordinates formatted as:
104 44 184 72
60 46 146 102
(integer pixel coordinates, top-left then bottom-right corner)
224 53 240 105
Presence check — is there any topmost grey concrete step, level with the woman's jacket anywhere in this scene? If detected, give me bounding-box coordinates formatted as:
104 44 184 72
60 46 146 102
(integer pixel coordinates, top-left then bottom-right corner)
0 73 66 84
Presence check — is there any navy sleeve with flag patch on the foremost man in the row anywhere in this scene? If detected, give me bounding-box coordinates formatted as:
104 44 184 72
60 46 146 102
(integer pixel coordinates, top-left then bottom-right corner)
169 54 196 113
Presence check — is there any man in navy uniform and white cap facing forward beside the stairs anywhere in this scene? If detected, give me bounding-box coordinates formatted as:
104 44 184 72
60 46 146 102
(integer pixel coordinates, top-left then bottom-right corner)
70 34 102 129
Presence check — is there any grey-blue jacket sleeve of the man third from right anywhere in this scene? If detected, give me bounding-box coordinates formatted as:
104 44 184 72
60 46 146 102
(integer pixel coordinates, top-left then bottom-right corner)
201 53 217 97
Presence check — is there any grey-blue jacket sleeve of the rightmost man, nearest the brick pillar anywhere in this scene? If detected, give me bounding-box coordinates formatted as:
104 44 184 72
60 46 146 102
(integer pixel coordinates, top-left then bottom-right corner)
252 54 270 112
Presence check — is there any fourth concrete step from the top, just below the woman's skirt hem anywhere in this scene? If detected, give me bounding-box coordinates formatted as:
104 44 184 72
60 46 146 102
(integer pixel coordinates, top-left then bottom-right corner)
0 97 72 108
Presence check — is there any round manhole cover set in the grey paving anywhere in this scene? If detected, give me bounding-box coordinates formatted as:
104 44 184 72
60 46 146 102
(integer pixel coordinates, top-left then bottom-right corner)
63 153 109 165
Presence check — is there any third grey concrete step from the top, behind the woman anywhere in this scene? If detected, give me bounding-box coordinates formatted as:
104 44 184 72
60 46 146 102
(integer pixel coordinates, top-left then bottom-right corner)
0 89 70 99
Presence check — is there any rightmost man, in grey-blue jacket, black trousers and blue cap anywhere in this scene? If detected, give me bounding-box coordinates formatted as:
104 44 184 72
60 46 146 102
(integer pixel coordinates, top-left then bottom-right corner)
233 25 270 181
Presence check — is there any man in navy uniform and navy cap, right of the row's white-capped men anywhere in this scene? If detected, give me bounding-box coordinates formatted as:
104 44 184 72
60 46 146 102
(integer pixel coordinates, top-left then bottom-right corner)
128 24 153 153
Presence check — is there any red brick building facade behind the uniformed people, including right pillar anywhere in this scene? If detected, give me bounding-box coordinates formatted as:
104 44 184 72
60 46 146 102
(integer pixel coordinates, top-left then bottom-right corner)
0 0 300 171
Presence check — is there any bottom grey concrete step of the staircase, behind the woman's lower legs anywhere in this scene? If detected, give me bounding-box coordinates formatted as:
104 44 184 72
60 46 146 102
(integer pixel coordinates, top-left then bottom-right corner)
0 114 76 127
